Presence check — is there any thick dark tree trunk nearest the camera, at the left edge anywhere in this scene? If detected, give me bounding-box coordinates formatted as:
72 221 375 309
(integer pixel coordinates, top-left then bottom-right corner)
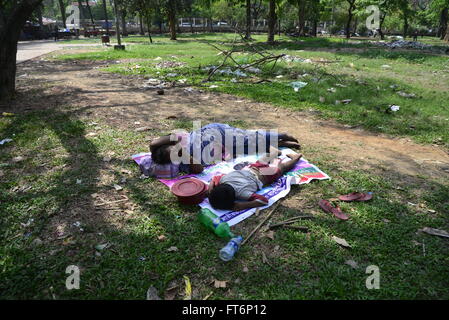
0 0 42 100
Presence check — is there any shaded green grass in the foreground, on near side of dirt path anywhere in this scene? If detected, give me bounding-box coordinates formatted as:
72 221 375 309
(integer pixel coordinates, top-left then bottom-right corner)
0 110 449 299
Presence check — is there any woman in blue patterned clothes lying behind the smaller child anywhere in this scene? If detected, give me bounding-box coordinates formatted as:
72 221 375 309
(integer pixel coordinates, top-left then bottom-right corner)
141 123 300 178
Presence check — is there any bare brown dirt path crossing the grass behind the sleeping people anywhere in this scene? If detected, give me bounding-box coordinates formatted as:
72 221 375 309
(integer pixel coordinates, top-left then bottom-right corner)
9 55 449 178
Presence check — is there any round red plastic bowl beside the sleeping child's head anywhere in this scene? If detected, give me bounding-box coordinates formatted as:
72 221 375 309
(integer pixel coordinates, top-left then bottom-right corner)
171 178 207 205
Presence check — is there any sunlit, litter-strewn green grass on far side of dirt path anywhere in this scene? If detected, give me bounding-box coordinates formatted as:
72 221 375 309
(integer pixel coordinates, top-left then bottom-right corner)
59 34 449 148
